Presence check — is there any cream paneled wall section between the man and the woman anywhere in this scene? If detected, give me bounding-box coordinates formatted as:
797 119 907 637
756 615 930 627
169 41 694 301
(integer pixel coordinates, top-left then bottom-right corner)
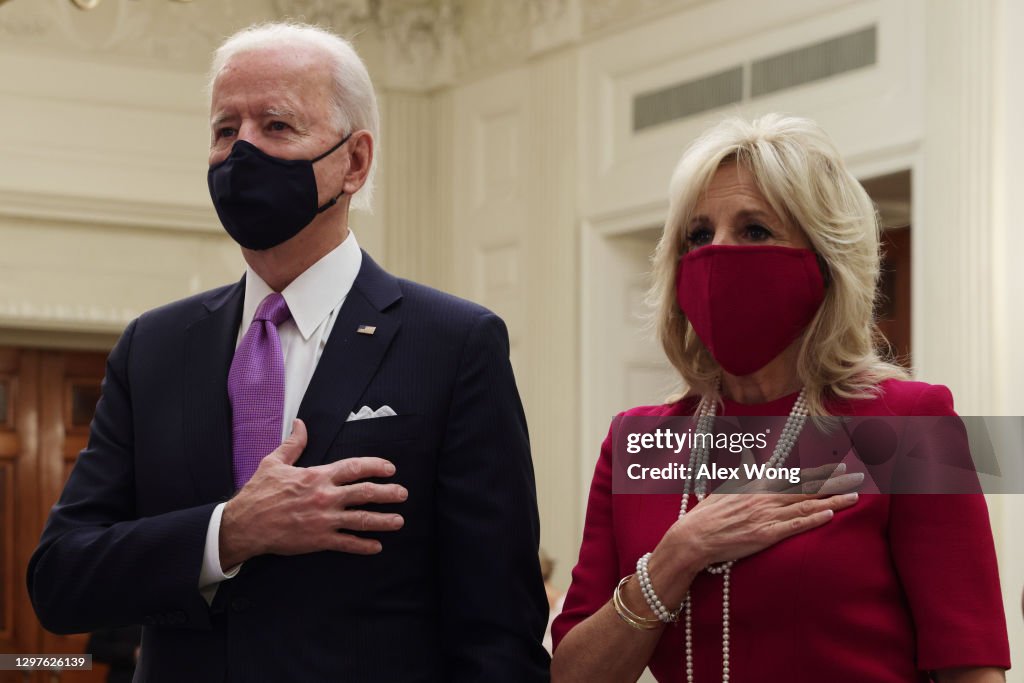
453 52 580 587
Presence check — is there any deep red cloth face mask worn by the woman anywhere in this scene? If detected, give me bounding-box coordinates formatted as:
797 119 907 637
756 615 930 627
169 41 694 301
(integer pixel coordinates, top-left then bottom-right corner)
676 246 824 376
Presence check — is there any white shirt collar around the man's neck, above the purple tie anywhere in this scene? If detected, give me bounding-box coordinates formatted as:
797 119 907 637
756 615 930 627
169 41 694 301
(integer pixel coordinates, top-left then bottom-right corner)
242 230 362 341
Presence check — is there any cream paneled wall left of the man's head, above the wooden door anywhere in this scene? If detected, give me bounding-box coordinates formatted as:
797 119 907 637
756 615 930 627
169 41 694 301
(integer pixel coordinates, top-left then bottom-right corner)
0 0 276 348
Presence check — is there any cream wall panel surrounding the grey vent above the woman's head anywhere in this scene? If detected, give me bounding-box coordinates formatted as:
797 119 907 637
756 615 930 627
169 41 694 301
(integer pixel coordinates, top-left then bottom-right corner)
581 0 924 220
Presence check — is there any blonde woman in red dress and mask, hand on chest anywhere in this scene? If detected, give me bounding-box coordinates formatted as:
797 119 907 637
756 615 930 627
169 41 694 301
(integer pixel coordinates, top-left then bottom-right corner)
552 115 1010 683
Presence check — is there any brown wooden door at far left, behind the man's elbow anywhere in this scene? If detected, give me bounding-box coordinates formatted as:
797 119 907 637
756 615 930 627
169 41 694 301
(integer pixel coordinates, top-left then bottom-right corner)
0 348 106 683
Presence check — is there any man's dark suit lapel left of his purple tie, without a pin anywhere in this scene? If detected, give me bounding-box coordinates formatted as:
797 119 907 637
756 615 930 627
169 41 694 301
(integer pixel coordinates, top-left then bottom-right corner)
184 279 245 503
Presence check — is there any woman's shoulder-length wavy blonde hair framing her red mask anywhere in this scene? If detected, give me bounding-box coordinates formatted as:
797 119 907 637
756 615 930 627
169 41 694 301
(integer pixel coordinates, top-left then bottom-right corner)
648 114 907 416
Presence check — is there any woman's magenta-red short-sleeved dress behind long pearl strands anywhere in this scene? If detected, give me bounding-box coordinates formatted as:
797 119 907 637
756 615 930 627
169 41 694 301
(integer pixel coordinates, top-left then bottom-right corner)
552 380 1010 683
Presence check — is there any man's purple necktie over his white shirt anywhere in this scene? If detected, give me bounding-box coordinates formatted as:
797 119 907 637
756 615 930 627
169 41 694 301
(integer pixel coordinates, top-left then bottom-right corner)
227 292 292 488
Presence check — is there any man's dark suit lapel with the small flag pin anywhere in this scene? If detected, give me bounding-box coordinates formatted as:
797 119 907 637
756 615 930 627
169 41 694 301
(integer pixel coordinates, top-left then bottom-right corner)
297 252 401 467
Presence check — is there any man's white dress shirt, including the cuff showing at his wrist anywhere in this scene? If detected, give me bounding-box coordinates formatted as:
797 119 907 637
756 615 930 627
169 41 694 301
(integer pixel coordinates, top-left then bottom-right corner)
199 231 362 603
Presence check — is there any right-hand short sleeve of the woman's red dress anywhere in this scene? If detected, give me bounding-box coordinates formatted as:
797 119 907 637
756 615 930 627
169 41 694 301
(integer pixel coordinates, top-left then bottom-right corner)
889 386 1010 671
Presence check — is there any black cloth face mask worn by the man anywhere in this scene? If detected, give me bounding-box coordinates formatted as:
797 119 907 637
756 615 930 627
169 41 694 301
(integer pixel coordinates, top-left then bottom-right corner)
206 133 352 250
